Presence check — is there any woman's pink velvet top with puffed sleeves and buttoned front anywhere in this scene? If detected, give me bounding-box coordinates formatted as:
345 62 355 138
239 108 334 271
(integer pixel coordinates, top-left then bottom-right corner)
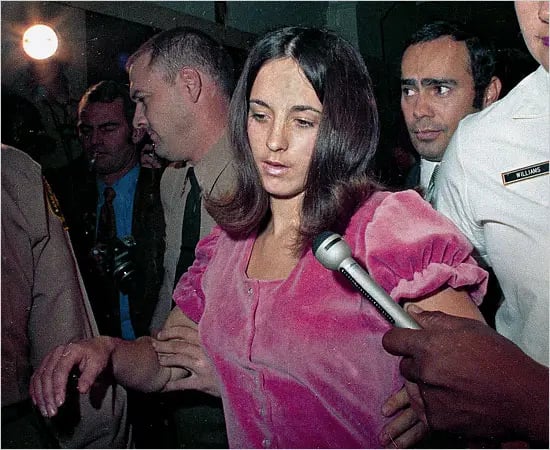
174 191 487 448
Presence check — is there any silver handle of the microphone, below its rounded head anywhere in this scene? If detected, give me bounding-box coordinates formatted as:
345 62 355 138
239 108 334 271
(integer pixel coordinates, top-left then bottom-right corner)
339 258 421 330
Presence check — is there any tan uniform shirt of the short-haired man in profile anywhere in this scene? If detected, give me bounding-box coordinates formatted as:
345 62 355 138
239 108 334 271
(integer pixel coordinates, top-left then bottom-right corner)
151 134 235 330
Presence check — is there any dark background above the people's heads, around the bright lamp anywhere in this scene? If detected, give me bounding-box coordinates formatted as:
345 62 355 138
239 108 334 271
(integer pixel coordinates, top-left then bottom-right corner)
1 1 536 172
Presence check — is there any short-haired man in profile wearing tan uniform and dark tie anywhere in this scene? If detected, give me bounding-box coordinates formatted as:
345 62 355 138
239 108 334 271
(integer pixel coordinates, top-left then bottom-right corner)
126 27 235 448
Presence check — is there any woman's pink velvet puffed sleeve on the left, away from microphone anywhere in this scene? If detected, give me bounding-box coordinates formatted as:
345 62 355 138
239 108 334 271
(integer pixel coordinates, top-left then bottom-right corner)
173 226 222 323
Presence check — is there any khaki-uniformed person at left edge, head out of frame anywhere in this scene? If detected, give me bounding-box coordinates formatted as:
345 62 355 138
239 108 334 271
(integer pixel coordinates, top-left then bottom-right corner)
1 145 129 448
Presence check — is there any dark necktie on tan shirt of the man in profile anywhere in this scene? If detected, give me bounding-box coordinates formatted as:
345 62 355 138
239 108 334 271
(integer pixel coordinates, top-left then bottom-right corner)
174 167 201 287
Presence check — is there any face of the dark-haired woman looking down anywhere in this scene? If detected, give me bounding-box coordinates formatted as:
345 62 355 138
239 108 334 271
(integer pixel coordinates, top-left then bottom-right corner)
248 58 323 198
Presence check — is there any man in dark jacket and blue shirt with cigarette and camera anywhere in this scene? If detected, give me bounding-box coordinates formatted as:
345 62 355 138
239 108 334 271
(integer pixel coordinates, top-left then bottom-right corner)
74 81 165 339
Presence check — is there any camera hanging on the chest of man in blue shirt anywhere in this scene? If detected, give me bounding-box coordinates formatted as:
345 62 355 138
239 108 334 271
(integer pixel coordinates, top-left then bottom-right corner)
91 236 136 294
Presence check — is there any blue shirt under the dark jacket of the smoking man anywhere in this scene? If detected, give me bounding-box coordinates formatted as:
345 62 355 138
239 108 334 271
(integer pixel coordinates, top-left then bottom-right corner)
96 164 140 339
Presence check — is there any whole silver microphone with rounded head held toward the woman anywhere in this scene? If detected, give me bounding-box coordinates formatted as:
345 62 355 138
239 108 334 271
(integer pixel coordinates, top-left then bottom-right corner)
313 231 421 330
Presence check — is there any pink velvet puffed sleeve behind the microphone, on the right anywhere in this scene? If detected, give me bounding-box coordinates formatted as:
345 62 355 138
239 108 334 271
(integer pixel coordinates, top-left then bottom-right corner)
365 191 487 305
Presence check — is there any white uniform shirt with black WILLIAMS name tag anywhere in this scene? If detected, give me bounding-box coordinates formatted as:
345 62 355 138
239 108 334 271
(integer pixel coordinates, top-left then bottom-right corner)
435 66 550 365
